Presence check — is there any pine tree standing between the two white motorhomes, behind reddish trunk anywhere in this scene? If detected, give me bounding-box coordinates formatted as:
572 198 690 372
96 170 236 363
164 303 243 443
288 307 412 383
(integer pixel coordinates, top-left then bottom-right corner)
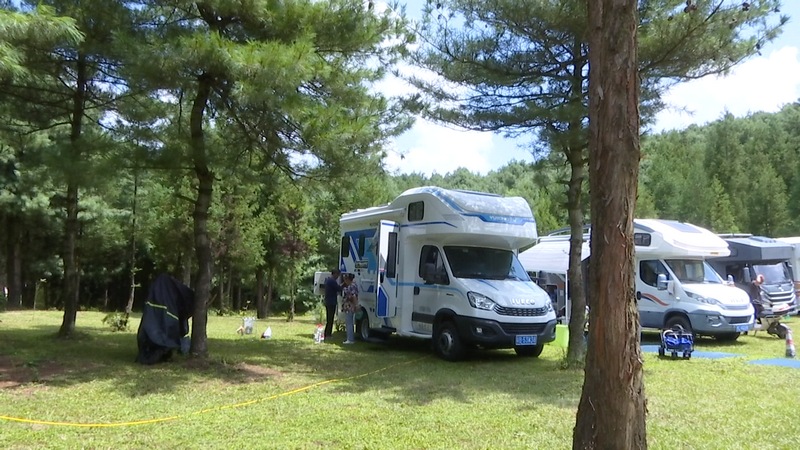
411 0 788 365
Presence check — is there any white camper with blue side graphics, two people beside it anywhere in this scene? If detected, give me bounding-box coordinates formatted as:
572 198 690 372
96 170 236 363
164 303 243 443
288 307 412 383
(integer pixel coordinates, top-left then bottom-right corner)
340 187 556 360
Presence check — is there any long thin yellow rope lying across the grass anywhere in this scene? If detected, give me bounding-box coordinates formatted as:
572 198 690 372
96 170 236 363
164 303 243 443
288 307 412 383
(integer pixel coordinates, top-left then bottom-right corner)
0 357 426 428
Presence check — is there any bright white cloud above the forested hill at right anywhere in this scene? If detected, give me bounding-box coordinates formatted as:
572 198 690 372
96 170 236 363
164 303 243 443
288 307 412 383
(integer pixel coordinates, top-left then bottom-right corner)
654 46 800 131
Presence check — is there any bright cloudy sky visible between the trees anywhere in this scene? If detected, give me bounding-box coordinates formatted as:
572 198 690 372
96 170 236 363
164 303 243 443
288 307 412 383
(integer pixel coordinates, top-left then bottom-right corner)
378 0 800 175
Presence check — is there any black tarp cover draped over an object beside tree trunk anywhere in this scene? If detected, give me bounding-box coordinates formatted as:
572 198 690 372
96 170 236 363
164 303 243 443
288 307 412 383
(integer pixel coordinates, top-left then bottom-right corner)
136 274 194 364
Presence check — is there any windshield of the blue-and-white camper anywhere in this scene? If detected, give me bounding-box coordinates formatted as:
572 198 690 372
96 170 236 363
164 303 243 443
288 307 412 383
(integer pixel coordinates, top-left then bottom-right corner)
444 246 530 281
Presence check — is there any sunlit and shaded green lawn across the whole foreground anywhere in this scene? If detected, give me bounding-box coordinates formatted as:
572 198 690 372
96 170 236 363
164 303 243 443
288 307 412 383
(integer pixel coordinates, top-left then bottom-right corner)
0 311 800 449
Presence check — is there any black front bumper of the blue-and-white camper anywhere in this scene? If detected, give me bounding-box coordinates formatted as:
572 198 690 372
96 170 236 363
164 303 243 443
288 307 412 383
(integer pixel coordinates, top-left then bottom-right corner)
455 316 556 348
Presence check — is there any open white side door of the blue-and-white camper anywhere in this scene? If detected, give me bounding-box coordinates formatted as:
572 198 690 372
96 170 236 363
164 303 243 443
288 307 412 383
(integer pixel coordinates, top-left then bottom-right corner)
375 220 400 317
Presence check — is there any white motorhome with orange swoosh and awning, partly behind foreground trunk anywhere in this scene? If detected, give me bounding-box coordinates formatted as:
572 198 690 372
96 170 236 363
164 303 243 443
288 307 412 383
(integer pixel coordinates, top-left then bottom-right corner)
520 219 754 340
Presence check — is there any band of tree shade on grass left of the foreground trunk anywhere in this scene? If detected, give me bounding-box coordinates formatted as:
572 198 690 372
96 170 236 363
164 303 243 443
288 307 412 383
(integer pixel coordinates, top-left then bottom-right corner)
0 318 583 407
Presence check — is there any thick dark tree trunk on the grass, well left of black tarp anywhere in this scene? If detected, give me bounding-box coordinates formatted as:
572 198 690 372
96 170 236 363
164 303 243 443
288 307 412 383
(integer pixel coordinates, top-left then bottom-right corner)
58 53 88 338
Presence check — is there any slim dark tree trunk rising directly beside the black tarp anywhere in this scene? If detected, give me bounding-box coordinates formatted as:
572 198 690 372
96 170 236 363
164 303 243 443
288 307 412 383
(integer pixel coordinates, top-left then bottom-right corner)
189 74 214 357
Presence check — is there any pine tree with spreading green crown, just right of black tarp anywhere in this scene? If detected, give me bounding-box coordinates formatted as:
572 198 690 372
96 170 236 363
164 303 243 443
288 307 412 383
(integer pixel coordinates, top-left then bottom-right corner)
130 0 409 356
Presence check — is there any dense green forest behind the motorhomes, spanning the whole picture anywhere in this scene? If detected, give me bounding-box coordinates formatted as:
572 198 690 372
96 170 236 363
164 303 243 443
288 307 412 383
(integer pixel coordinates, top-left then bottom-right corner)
0 1 800 326
